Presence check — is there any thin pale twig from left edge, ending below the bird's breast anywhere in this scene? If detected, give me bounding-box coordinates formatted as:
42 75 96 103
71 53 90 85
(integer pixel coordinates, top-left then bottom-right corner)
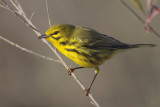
0 36 60 62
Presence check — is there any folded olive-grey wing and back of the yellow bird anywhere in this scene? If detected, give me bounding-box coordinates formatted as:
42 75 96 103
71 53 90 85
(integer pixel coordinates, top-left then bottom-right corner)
72 28 128 49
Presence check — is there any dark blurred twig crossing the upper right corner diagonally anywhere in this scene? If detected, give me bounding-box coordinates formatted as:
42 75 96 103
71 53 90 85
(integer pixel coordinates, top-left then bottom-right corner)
120 0 160 38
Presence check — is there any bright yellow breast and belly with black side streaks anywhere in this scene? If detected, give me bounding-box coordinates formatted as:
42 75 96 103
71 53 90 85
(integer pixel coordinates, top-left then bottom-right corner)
48 36 113 68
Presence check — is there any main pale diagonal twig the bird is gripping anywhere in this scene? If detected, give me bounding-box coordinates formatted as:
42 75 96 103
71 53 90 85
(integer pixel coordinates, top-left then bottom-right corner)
2 0 100 107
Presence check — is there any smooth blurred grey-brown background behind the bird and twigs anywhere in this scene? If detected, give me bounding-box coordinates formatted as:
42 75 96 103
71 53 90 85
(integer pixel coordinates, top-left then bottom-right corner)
0 0 160 107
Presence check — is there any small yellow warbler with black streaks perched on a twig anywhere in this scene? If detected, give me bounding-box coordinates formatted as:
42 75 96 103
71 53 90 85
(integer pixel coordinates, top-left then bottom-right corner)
39 24 156 95
